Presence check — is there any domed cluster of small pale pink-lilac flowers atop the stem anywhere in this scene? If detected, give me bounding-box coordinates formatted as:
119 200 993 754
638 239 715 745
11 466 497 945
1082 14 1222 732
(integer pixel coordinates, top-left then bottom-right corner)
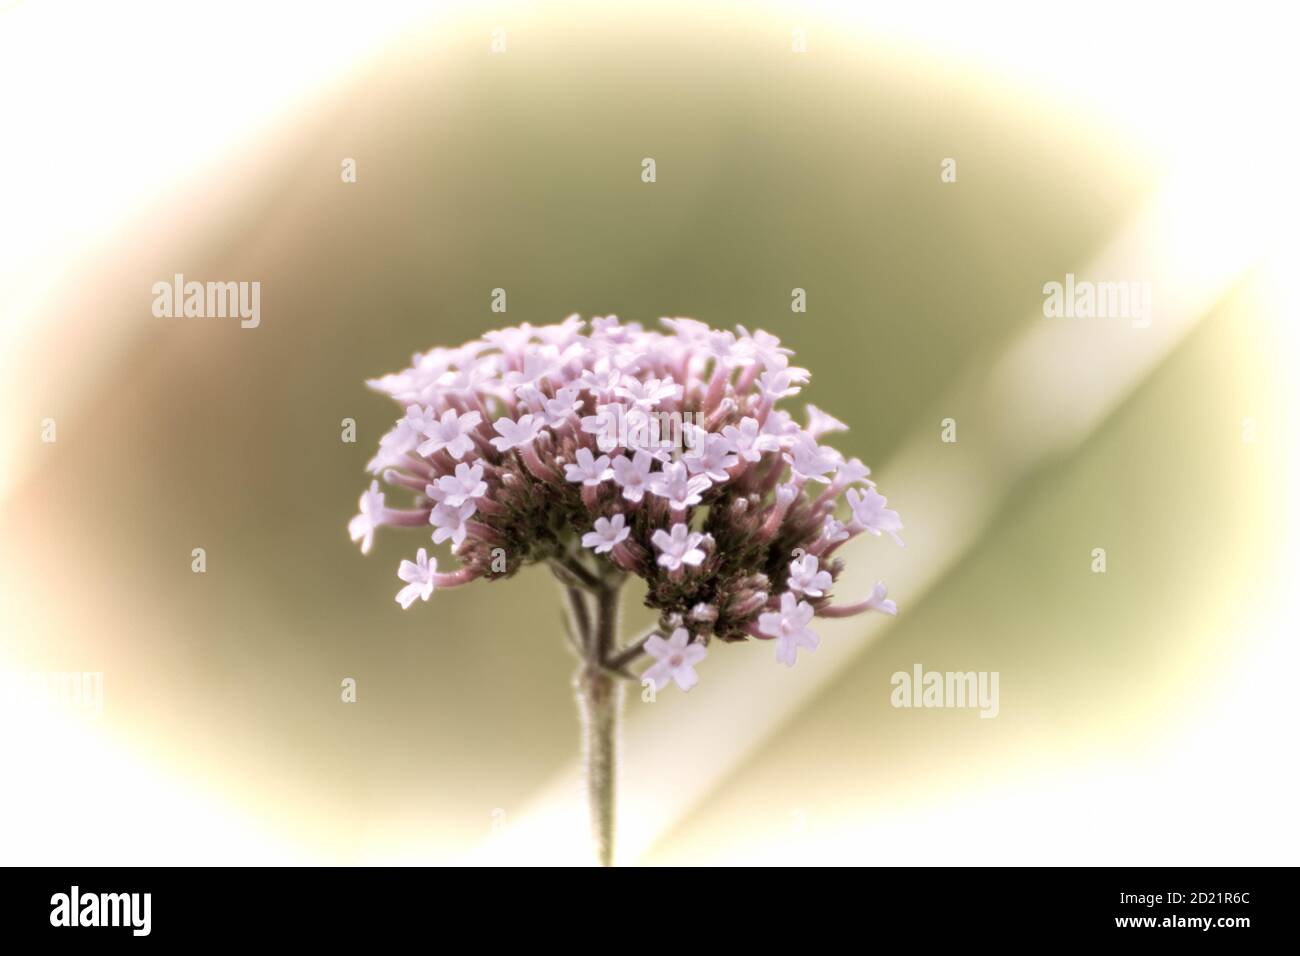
348 316 902 689
